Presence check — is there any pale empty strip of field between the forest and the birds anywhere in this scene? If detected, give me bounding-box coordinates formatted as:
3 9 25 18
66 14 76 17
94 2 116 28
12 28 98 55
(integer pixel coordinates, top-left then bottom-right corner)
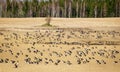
0 18 120 28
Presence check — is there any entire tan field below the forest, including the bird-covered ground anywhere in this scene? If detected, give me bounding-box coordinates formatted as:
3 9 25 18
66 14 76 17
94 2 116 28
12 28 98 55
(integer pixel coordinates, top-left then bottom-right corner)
0 18 120 72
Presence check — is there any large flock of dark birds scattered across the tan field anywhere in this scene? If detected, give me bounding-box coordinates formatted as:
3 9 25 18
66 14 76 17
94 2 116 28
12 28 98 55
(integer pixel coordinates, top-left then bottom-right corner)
0 28 120 68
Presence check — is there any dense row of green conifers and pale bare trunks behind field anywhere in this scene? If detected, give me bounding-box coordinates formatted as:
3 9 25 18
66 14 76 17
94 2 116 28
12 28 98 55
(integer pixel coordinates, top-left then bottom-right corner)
0 0 120 18
